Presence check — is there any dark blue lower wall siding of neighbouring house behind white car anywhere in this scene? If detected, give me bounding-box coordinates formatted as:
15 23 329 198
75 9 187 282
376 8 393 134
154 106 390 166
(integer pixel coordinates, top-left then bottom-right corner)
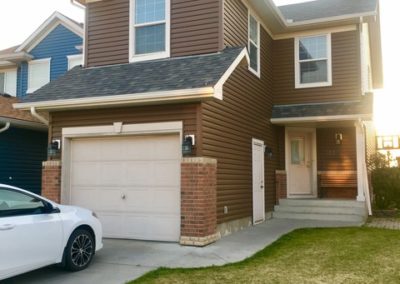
0 127 47 194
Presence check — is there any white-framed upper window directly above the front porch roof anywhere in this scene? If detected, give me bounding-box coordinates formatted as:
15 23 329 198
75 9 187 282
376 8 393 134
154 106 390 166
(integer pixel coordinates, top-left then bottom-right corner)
295 34 332 88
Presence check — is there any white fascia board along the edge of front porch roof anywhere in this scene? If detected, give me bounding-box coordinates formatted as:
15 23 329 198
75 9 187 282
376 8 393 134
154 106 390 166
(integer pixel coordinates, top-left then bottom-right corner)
271 114 372 124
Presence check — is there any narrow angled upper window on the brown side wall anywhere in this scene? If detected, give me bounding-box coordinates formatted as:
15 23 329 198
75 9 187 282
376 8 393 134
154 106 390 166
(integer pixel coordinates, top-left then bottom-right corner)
248 14 260 77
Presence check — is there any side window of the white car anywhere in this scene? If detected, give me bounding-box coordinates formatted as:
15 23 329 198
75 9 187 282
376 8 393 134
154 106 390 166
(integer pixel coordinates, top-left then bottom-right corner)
0 188 45 217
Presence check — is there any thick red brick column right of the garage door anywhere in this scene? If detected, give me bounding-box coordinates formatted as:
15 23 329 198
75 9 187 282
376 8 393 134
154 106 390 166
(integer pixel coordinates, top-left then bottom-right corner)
180 157 220 246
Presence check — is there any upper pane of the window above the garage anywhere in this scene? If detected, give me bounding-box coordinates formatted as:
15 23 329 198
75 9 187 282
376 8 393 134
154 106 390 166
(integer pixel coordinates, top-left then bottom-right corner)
135 0 165 24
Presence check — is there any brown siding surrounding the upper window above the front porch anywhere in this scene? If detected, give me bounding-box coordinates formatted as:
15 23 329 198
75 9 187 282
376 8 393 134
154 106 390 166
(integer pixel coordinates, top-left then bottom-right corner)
273 31 361 104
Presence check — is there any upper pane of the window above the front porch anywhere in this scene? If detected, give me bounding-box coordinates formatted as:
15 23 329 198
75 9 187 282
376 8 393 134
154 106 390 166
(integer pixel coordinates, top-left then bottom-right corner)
299 36 328 60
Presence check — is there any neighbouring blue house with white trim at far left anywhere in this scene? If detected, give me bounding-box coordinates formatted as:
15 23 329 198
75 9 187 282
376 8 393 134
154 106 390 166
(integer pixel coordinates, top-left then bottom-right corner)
0 12 83 193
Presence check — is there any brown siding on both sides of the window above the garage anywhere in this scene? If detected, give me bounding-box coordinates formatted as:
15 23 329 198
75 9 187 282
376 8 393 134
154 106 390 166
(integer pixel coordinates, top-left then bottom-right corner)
85 0 223 67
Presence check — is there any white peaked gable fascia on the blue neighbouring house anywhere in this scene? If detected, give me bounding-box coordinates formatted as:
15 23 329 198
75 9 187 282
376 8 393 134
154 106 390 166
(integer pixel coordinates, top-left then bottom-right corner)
15 11 84 52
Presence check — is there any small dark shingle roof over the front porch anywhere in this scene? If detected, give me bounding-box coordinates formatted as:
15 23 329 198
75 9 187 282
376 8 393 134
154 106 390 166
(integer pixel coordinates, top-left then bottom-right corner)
272 95 373 118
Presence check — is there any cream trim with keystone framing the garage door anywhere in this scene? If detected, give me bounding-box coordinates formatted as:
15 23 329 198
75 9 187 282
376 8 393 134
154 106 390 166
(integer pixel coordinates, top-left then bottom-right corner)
61 121 183 204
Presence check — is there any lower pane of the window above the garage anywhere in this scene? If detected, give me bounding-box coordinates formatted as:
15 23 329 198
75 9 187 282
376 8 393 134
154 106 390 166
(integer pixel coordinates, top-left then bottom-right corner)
135 24 165 54
